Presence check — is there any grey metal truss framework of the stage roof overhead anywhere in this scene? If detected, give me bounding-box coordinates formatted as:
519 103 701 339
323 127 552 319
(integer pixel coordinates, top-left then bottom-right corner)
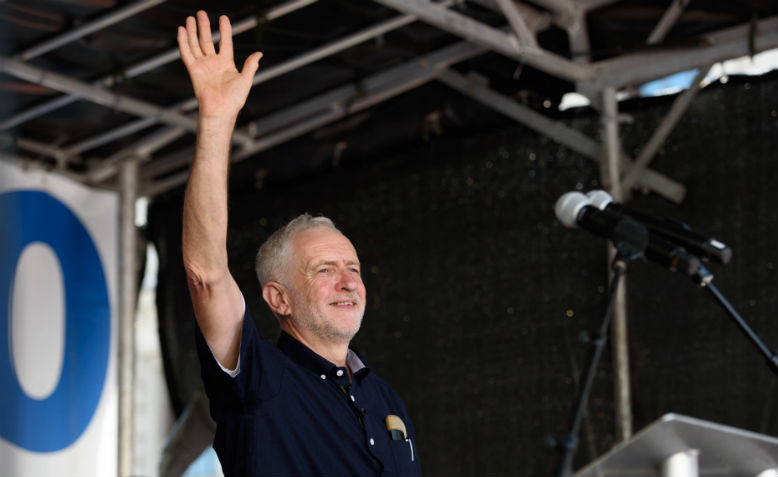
0 0 778 201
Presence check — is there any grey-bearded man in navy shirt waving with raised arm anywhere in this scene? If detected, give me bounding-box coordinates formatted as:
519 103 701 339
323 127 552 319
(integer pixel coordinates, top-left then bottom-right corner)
178 11 421 476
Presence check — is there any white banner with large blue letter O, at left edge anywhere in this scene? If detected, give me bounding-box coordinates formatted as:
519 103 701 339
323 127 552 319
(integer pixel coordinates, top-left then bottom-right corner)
0 161 118 476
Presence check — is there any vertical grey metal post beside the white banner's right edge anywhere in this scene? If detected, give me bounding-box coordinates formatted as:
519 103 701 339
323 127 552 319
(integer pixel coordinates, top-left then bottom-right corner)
118 159 138 477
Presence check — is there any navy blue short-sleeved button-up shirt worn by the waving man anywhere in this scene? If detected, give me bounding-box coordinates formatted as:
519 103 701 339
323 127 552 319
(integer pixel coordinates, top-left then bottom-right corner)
195 310 421 476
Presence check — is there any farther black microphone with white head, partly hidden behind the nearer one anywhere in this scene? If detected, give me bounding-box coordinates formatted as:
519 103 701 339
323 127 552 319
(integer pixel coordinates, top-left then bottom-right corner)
586 190 732 265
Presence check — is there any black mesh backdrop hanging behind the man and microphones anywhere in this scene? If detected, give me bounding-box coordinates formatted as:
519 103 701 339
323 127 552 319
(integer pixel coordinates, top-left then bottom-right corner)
149 75 778 475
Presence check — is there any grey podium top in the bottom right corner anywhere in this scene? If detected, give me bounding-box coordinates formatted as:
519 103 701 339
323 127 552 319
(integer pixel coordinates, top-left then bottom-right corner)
575 414 778 477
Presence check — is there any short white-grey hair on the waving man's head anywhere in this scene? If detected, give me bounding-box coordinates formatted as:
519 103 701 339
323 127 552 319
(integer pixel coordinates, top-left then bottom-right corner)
254 213 340 287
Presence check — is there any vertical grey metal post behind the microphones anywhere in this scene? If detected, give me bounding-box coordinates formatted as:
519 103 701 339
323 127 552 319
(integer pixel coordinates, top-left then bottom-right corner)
600 87 632 440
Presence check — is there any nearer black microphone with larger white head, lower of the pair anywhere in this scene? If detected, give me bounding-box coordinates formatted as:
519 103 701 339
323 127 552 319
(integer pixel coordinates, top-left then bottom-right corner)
554 191 700 276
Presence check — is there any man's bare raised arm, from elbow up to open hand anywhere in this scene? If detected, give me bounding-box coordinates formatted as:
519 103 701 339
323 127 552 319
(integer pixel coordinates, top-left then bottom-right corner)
178 11 262 369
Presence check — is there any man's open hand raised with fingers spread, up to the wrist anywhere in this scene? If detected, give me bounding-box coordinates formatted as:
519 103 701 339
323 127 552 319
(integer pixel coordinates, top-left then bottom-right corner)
178 10 262 120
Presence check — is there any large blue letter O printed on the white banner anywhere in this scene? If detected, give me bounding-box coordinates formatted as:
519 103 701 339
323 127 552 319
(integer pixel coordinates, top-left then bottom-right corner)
0 190 111 452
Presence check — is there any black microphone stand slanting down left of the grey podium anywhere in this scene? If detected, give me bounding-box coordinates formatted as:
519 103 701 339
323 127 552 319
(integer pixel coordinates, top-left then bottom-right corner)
555 240 646 477
